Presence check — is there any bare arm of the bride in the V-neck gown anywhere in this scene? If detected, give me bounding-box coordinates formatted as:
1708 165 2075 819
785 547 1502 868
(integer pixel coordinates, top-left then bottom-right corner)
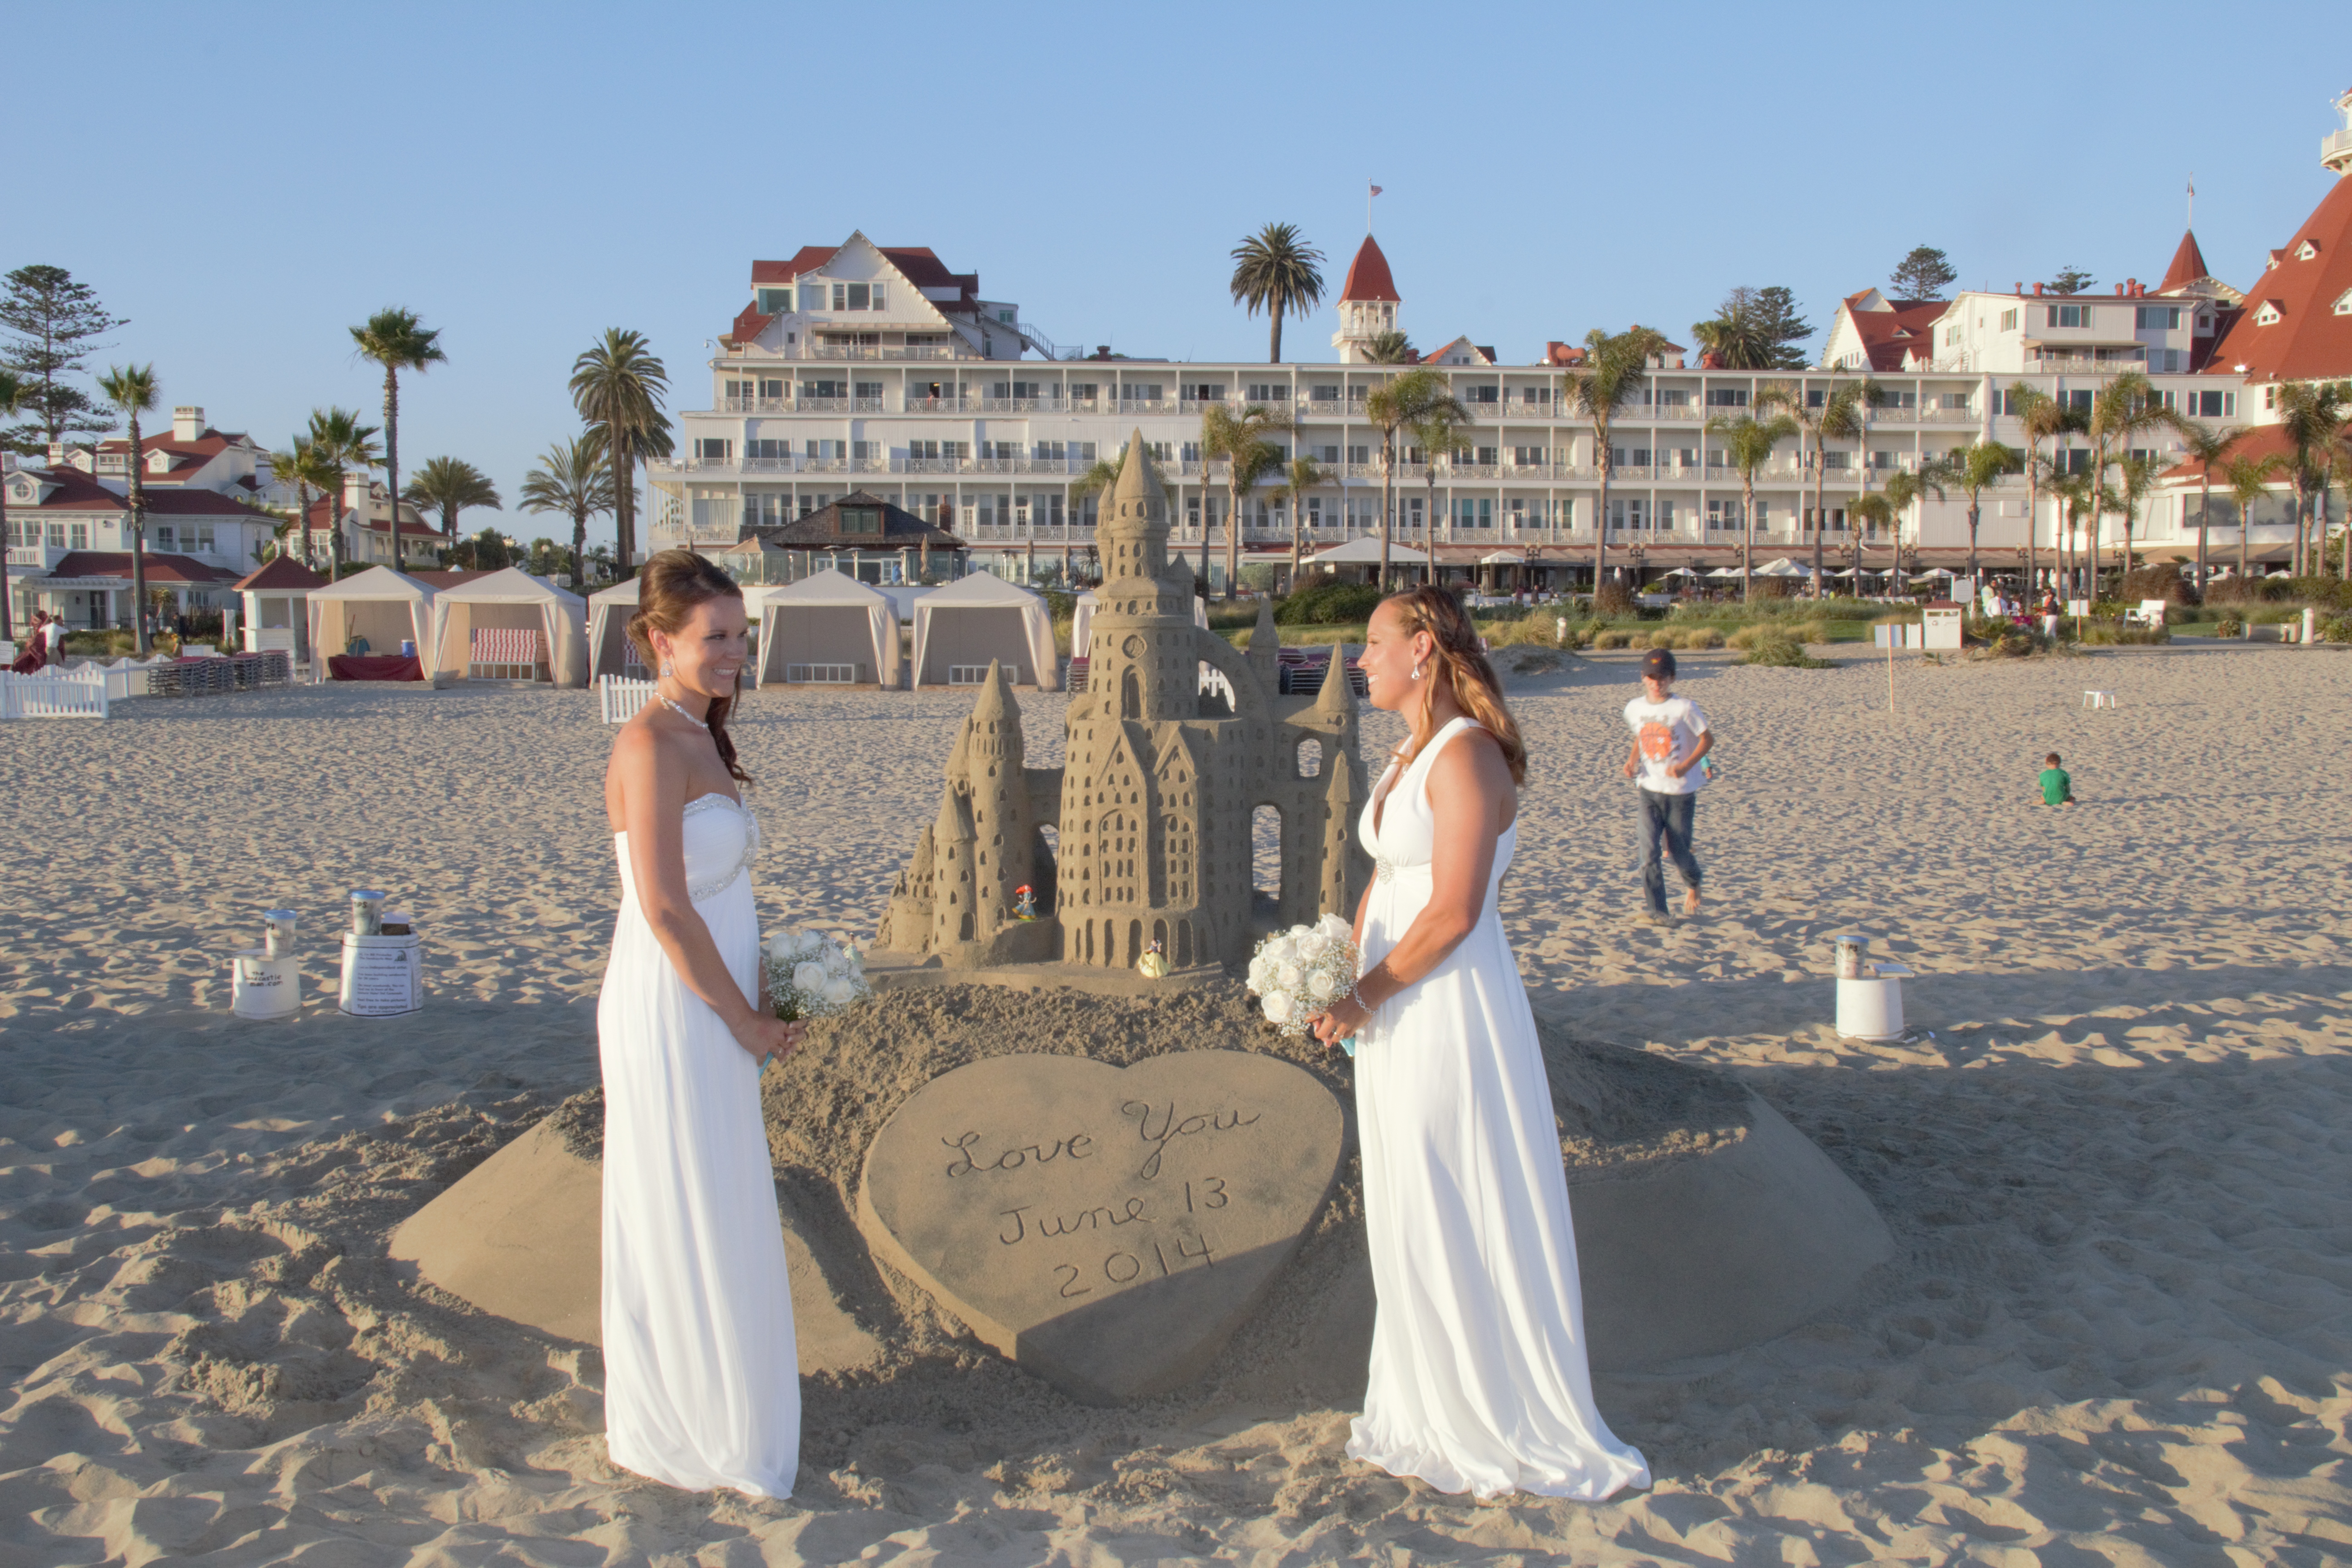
1315 731 1517 1044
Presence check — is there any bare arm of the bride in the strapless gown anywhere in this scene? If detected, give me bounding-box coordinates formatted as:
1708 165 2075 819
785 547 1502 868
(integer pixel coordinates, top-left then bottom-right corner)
612 724 793 1058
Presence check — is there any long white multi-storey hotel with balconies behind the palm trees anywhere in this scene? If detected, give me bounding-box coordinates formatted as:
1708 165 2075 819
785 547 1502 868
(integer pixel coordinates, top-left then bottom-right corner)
644 160 2352 585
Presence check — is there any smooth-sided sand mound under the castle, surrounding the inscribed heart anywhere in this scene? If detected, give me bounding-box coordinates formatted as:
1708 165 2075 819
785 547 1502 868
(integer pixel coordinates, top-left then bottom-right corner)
393 985 1893 1401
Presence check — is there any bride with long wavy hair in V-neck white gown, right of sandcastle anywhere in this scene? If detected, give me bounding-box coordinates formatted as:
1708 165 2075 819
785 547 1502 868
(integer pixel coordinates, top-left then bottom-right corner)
1315 588 1649 1500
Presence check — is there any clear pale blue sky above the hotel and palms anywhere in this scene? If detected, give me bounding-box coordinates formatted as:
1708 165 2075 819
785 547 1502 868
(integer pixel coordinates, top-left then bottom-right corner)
14 0 2352 552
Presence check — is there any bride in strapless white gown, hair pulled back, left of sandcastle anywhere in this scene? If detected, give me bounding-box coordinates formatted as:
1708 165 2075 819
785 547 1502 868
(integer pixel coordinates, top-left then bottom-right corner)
598 550 800 1498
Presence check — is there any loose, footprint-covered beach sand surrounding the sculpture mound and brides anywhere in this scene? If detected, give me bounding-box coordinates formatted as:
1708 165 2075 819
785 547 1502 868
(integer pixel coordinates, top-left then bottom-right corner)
0 647 2352 1568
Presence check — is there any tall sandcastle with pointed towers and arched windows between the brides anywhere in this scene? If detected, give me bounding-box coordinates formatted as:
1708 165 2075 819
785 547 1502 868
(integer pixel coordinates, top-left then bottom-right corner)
877 430 1371 969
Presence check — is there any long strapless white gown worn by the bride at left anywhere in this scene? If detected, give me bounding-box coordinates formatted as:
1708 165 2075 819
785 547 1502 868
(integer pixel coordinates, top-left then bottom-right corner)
595 794 800 1498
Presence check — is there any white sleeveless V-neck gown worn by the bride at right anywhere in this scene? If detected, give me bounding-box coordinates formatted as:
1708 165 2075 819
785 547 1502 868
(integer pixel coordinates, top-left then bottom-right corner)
1348 720 1649 1500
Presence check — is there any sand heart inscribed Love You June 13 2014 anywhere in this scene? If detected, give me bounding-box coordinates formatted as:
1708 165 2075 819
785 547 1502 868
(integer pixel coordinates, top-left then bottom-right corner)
858 1051 1345 1403
